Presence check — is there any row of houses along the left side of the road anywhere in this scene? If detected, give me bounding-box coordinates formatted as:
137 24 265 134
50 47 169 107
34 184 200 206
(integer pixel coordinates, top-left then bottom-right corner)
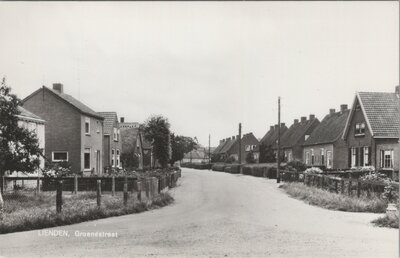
18 83 152 175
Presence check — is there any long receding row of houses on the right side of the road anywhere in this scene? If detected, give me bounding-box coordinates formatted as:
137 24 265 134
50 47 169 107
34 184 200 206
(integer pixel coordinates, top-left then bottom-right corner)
214 86 400 171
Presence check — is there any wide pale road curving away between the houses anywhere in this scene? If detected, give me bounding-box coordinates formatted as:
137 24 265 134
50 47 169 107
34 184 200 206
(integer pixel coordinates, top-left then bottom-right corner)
0 169 398 258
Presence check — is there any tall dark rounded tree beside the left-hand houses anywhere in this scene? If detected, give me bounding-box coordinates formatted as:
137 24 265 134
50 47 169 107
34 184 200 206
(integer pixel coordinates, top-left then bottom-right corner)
141 115 170 167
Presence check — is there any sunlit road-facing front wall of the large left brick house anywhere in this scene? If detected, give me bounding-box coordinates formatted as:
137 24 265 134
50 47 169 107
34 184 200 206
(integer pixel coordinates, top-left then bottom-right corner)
80 115 104 175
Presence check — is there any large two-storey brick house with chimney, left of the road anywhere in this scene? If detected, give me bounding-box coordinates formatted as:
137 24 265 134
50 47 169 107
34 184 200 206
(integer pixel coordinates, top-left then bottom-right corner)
22 83 104 175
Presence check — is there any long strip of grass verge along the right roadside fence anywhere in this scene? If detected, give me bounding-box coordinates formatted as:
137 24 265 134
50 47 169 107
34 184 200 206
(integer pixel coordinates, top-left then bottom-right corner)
281 183 387 213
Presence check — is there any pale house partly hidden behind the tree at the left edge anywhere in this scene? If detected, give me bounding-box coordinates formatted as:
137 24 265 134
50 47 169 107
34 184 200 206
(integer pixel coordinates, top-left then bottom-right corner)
17 106 46 173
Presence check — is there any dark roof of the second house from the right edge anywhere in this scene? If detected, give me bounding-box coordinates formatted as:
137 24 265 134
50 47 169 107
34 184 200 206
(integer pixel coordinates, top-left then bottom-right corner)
304 110 350 145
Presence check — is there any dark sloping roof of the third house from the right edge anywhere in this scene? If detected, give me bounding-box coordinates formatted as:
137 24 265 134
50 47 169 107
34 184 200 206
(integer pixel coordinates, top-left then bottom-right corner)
281 118 319 148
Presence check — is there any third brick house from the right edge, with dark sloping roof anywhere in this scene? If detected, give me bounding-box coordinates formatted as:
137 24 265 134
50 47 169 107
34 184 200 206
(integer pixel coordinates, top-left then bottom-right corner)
281 115 319 162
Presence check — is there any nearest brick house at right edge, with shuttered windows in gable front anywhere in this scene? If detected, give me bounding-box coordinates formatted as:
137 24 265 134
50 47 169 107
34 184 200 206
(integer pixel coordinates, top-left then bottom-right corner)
343 86 400 171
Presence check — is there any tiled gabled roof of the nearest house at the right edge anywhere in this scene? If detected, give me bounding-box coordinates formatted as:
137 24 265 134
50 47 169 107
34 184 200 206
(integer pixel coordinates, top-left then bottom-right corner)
343 92 400 138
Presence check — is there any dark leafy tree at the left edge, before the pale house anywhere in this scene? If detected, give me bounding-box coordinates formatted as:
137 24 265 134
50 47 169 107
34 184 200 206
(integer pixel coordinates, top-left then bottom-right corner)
0 78 43 211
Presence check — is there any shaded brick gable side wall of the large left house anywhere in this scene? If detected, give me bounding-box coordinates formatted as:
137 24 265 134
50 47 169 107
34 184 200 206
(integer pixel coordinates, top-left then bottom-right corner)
23 89 81 172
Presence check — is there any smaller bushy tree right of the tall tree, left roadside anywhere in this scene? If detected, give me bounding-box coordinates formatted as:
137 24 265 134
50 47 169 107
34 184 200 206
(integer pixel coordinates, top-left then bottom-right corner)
169 133 197 166
